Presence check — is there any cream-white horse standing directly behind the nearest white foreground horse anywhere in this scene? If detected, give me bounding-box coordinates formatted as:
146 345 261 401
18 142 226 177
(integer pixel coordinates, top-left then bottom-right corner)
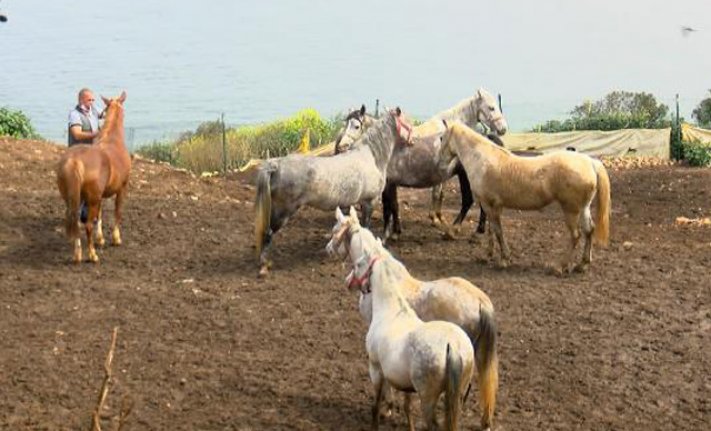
326 209 499 430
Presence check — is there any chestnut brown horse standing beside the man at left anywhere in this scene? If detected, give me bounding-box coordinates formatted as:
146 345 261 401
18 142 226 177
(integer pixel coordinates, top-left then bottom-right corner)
57 91 131 263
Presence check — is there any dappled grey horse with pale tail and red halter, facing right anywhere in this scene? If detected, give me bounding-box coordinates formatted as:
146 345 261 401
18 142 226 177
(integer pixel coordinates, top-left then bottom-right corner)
254 108 412 276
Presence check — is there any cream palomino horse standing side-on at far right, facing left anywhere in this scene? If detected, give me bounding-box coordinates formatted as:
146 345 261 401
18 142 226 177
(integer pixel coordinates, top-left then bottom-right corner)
440 122 611 273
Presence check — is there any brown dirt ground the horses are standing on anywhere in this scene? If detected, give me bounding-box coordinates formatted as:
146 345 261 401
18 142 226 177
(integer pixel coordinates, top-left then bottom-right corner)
0 140 711 430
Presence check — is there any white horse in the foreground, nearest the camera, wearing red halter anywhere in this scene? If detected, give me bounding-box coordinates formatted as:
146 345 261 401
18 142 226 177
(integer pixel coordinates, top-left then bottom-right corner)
329 210 474 430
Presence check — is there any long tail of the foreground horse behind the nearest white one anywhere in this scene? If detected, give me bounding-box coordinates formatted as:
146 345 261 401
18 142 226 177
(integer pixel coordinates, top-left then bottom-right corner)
474 308 499 429
